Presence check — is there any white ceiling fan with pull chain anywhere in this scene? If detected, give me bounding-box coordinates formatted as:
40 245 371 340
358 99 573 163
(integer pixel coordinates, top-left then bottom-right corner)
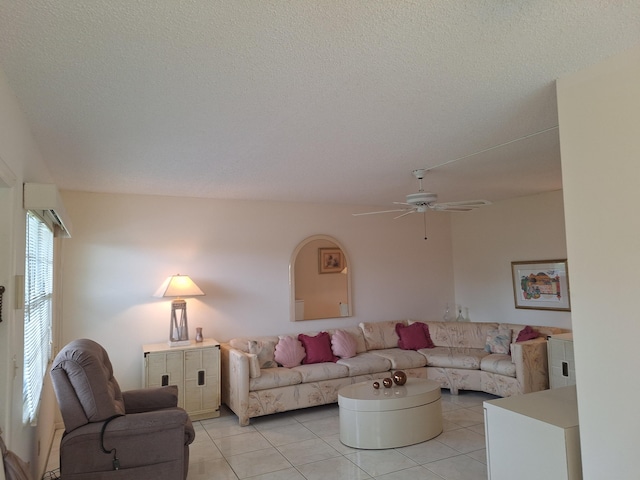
352 168 491 240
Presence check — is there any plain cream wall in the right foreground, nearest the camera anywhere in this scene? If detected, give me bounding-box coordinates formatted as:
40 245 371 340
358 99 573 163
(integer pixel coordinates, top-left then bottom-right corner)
557 47 640 480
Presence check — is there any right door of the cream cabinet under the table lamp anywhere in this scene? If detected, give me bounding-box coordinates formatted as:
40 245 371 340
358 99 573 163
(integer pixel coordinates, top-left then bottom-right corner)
184 347 220 419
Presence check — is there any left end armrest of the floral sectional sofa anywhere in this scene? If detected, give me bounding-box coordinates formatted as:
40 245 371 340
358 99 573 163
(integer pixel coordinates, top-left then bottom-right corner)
220 343 250 425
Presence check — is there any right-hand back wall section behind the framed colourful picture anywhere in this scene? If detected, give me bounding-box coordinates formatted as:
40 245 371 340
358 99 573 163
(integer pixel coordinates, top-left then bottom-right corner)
452 191 572 328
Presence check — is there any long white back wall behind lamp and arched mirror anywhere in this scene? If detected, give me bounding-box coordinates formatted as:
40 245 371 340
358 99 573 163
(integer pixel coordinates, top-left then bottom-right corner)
63 192 453 389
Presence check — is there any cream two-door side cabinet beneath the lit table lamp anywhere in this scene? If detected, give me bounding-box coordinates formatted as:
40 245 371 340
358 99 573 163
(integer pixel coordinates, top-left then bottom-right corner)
142 339 220 420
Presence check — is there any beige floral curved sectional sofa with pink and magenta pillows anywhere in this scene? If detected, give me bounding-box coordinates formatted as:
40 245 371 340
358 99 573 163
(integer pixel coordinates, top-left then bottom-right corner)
221 320 567 425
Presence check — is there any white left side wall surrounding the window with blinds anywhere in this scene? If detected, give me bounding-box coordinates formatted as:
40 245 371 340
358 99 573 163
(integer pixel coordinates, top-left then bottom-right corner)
0 67 55 478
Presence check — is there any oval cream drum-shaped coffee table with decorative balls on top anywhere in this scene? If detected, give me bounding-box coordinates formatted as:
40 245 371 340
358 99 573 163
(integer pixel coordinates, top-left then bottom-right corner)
338 378 442 449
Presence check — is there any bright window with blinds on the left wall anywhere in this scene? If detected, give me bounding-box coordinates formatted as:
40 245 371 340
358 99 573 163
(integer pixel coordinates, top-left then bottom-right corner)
22 212 53 423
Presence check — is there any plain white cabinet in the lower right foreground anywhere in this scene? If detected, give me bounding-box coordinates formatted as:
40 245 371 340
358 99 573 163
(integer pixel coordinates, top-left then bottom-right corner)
484 385 582 480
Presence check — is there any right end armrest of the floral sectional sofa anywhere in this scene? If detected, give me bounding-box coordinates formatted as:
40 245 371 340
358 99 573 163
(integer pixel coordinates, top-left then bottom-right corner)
511 337 549 393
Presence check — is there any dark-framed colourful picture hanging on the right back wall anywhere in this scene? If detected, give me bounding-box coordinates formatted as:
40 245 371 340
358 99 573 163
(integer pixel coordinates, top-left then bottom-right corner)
511 259 571 312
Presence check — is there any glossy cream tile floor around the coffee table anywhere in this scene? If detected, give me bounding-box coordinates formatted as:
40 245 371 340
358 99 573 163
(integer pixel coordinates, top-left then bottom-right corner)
48 390 498 480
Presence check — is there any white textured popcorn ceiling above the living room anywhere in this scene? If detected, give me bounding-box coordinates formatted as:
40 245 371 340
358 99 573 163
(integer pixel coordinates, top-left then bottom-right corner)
0 0 640 205
